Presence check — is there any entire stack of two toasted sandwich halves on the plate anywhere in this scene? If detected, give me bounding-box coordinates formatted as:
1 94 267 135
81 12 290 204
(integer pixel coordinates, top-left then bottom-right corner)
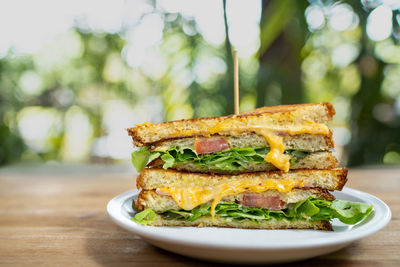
128 103 372 230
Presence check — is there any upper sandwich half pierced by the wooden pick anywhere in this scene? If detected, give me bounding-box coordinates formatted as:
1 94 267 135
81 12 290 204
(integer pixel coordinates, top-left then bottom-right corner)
128 103 337 174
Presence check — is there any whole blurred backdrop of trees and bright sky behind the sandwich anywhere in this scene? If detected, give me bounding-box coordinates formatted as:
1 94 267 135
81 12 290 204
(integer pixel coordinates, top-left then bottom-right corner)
0 0 400 171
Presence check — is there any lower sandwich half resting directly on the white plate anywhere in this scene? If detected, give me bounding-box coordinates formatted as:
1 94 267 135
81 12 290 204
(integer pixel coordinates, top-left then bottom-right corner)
134 168 372 230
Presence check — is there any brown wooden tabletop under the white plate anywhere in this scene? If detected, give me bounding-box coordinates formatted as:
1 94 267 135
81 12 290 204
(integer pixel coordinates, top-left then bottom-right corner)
0 168 400 266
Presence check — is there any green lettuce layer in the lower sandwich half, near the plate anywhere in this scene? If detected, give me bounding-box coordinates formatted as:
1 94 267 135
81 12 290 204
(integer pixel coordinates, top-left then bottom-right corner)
132 197 373 225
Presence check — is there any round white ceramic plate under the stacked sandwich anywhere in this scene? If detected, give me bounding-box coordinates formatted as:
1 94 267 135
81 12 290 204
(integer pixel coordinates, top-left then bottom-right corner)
107 188 391 263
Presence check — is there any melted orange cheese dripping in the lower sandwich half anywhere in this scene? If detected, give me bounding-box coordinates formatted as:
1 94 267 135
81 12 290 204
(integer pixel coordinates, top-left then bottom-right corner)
157 179 304 221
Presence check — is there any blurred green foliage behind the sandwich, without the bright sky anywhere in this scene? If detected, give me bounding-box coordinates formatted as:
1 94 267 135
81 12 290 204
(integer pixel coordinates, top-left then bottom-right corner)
0 0 400 166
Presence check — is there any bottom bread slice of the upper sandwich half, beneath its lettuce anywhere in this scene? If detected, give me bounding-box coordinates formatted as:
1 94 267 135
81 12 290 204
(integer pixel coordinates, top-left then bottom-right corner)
149 152 338 174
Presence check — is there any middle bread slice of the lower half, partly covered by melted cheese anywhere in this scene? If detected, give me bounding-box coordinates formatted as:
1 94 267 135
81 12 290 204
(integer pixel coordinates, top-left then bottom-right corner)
136 188 335 212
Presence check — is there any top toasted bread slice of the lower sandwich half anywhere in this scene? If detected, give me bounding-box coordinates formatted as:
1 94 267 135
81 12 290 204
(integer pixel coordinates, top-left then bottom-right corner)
136 168 347 190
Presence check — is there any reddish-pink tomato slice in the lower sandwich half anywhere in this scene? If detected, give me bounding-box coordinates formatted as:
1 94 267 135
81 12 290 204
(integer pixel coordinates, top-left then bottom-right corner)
242 193 287 210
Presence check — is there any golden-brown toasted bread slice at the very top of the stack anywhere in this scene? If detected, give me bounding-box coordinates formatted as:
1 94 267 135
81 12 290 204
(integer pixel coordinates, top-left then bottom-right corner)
127 103 335 146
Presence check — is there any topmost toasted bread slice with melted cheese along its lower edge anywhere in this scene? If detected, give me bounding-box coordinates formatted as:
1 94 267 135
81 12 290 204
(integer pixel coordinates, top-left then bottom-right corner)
128 103 335 146
